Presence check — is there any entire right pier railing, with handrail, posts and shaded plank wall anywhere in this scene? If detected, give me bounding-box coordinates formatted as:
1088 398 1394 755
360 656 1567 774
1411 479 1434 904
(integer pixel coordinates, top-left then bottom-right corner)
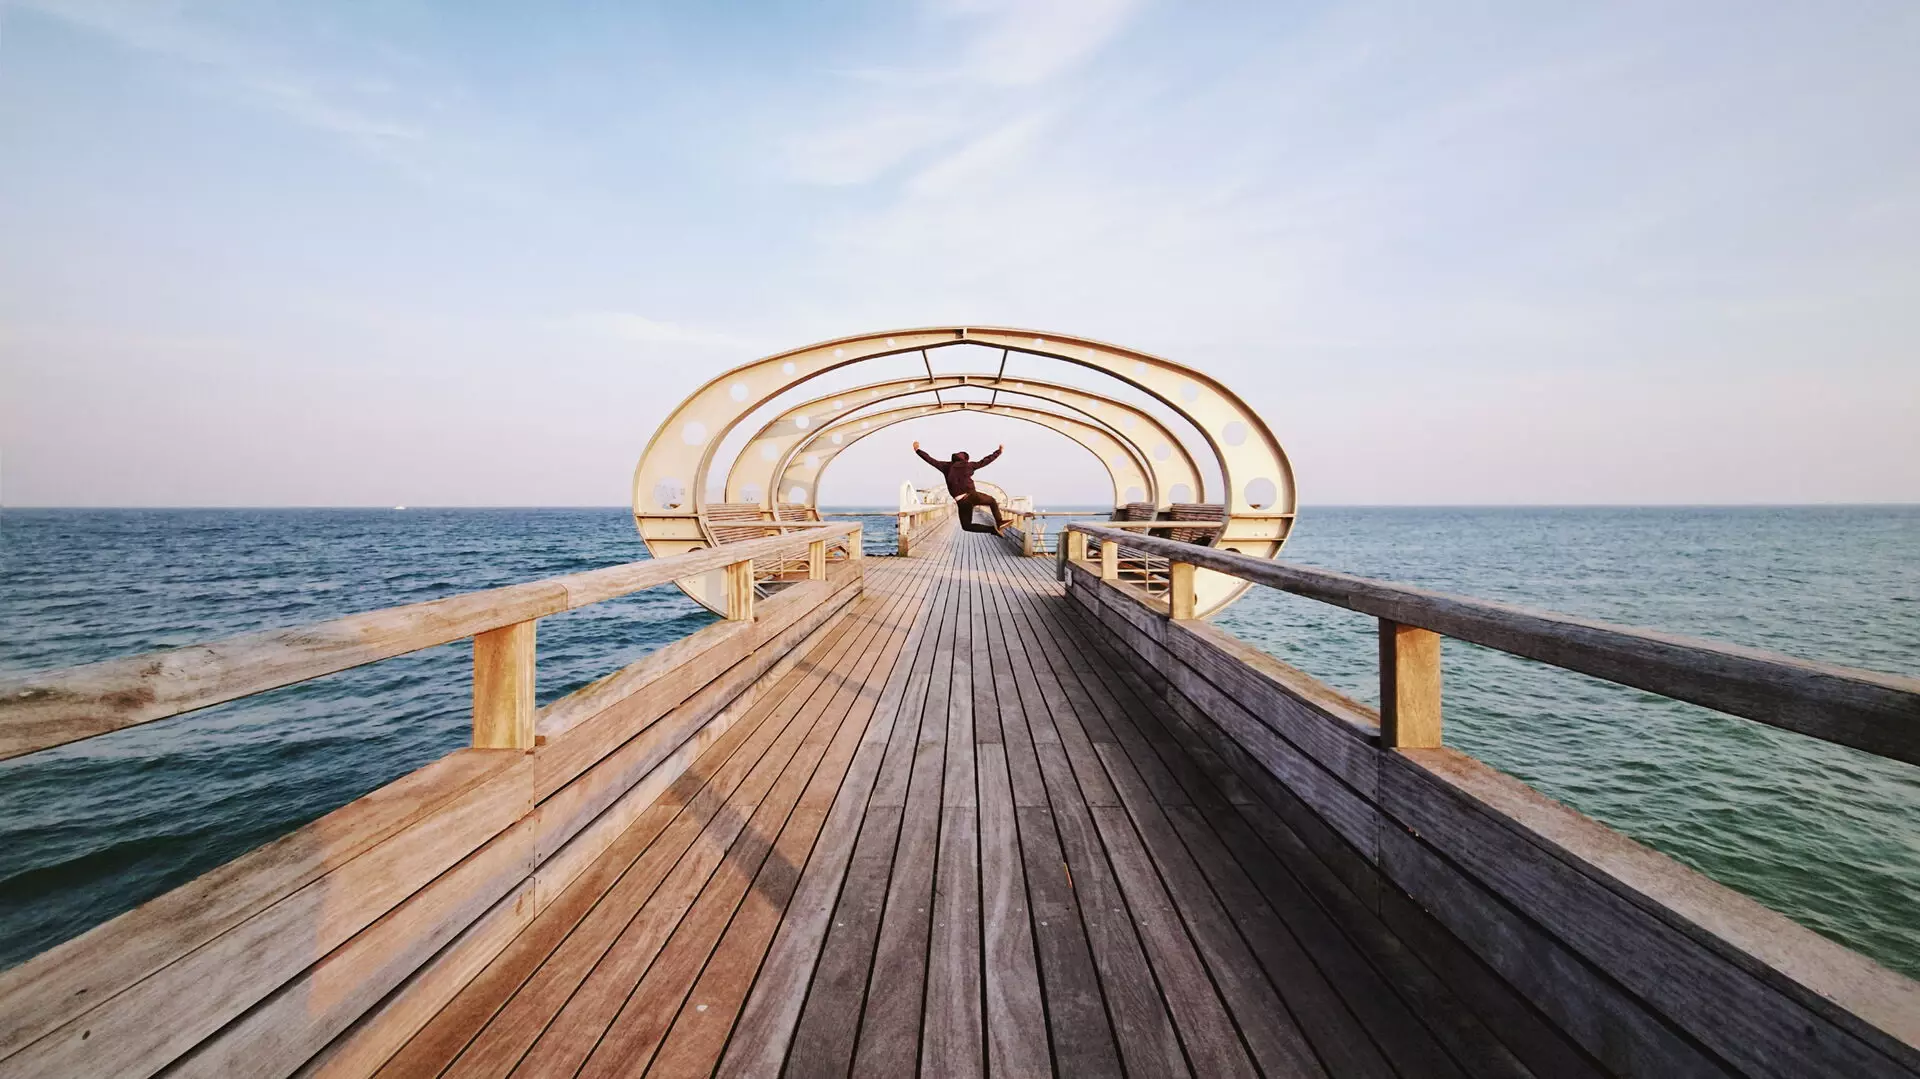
1062 524 1920 1079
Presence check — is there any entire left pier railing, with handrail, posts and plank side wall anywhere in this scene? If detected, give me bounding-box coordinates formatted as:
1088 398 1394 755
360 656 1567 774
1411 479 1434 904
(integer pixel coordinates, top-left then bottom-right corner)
0 522 864 1079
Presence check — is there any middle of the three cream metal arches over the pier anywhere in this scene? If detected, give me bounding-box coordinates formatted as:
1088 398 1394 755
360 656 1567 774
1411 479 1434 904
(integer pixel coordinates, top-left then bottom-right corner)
726 374 1206 509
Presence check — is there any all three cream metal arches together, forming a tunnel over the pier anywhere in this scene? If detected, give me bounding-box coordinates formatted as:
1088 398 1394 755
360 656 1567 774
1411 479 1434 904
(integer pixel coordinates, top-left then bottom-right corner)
634 326 1296 616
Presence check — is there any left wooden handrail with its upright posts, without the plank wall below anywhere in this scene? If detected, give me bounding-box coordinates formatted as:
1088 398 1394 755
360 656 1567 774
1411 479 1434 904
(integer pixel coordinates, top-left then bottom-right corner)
0 524 860 760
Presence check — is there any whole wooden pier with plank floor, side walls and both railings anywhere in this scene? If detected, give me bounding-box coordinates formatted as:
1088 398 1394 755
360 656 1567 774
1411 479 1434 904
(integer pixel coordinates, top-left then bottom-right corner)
0 515 1920 1079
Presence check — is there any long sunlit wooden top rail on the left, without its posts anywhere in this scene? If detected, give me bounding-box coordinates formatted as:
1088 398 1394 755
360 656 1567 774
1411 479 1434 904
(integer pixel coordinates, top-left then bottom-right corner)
0 522 860 760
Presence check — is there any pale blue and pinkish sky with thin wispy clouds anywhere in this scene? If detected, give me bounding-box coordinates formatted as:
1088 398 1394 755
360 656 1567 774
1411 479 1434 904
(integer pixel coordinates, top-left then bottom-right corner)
0 0 1920 507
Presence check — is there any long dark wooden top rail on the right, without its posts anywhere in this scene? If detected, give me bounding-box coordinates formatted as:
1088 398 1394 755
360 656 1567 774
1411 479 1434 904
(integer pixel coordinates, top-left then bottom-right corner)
1066 524 1920 764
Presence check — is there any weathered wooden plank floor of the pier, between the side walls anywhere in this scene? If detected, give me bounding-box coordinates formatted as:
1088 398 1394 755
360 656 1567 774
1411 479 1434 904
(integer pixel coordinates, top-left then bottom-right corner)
382 528 1599 1079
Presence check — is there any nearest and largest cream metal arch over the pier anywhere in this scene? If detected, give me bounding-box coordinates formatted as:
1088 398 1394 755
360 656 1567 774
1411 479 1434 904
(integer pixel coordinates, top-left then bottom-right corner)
634 326 1296 616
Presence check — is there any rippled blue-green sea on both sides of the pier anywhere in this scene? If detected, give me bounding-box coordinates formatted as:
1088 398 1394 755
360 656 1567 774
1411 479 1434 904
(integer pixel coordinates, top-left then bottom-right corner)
0 507 1920 977
